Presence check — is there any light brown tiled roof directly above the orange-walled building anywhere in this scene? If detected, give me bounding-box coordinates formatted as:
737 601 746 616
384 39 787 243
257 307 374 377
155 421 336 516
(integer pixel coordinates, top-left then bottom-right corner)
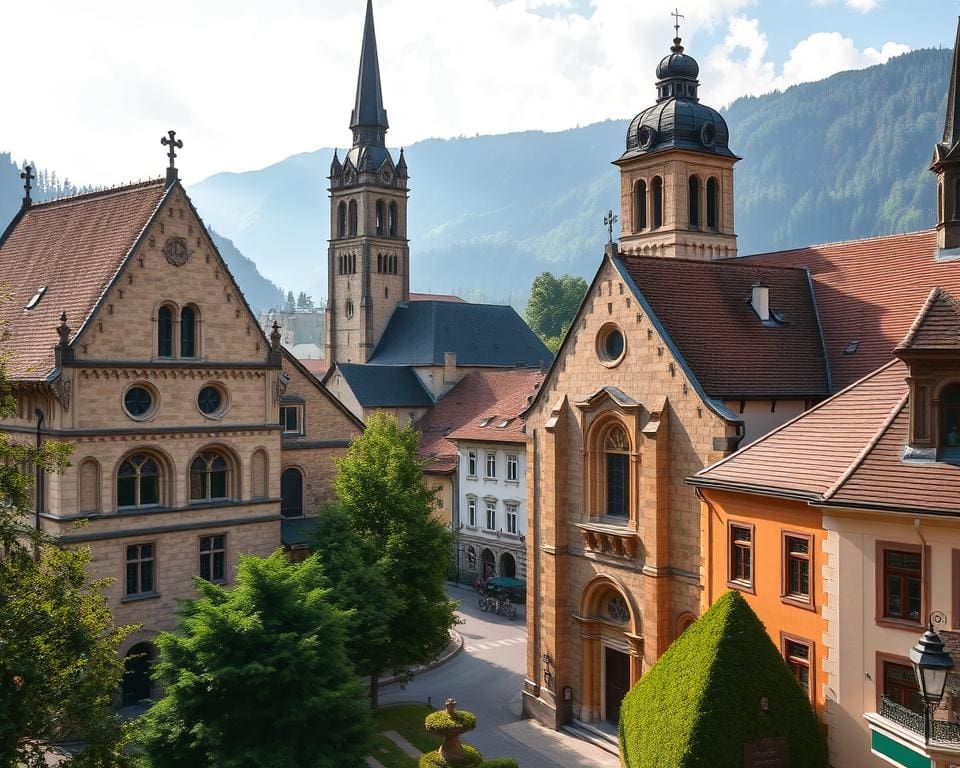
690 360 960 514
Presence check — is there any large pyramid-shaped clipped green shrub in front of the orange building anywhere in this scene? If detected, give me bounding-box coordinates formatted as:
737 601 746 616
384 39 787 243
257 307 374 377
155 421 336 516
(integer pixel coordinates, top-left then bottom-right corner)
619 591 827 768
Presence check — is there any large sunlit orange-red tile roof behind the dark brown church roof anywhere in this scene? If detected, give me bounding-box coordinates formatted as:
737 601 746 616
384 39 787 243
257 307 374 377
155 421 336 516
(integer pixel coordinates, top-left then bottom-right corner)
740 230 960 389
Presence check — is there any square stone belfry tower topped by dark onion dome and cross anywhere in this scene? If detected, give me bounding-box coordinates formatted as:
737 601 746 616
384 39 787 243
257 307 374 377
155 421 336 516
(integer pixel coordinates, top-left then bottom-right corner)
614 24 740 259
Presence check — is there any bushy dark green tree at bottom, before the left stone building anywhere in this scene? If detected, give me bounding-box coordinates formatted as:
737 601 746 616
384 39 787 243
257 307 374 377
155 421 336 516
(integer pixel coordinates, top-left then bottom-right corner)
143 552 372 768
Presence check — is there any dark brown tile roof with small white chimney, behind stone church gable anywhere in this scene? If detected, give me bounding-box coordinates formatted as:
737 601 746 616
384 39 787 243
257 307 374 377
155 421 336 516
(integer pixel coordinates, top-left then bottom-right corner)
616 254 829 398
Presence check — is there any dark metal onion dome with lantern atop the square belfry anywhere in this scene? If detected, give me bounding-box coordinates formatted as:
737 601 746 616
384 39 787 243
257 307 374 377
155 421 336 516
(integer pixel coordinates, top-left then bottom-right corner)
621 37 736 159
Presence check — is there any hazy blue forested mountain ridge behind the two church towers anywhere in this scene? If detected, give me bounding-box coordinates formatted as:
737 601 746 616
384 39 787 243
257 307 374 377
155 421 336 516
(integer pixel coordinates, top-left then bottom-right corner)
190 50 950 305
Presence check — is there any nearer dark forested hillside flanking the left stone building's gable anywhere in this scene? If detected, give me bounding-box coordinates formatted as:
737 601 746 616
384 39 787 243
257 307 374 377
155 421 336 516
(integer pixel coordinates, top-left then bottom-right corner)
0 152 284 312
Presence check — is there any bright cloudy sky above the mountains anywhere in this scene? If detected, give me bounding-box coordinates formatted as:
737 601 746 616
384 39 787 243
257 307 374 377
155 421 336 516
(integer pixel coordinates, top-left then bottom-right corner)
0 0 960 185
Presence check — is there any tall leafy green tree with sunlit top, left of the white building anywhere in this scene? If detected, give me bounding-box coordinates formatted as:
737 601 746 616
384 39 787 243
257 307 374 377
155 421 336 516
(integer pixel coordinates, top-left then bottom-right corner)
334 413 456 708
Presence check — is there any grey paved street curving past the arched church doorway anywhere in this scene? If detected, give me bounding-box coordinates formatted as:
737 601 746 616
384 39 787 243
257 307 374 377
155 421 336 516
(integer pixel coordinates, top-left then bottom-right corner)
380 586 619 768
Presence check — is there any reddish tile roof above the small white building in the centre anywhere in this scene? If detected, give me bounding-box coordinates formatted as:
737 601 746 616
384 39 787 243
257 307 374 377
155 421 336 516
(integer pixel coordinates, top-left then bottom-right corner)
417 368 544 471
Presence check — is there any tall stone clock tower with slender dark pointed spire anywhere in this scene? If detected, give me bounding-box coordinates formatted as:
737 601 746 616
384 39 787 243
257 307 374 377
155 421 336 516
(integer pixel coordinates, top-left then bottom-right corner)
326 0 410 365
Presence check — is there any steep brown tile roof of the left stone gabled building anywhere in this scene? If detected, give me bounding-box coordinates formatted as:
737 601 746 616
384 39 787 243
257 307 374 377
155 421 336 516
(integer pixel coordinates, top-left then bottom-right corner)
0 179 165 380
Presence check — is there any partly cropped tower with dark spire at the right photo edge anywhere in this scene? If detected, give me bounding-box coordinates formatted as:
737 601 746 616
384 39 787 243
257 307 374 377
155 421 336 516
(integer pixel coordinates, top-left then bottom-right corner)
930 20 960 250
